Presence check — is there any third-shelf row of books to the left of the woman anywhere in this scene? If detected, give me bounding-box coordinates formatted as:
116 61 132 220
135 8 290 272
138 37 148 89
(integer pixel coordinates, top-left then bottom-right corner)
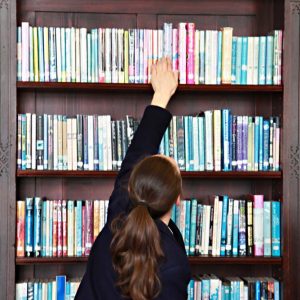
16 197 108 257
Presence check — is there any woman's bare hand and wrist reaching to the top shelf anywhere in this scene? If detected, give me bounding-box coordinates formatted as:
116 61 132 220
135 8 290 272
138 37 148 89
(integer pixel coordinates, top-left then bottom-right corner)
151 58 178 108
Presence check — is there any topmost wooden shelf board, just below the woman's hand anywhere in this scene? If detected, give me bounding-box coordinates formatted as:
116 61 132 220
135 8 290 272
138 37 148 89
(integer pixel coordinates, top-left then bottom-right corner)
17 81 283 93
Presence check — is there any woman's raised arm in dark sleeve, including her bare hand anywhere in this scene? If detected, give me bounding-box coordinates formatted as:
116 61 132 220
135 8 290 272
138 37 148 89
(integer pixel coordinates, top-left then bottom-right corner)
108 58 178 219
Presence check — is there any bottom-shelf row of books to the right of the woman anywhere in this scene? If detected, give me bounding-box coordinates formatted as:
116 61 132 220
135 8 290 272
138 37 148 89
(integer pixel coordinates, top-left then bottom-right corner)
188 275 281 300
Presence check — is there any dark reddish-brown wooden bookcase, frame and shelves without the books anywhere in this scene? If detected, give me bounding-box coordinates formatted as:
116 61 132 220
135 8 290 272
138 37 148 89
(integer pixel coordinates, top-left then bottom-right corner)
0 0 300 299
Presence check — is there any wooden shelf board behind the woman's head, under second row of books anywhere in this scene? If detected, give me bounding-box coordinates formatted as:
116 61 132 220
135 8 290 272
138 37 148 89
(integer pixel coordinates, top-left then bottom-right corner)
17 170 282 179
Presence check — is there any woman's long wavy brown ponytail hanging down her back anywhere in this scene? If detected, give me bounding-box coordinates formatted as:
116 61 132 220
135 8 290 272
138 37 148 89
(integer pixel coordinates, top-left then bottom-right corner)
111 204 164 300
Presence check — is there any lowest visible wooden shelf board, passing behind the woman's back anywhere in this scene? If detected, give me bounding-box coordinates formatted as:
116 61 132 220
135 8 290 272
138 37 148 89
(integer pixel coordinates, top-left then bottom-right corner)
16 256 282 265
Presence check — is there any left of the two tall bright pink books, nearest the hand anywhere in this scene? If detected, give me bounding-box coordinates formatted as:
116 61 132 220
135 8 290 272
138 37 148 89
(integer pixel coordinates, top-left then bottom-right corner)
178 23 186 84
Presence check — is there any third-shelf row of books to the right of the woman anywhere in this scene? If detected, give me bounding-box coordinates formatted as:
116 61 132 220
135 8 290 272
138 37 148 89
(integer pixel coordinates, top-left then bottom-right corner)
172 195 281 257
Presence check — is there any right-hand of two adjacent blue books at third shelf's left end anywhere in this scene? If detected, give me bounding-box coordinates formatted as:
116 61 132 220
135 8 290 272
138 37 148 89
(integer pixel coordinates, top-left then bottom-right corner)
33 197 42 257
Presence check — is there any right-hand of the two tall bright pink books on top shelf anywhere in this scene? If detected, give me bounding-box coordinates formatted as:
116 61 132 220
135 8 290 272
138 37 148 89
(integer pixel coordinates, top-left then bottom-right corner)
186 23 195 84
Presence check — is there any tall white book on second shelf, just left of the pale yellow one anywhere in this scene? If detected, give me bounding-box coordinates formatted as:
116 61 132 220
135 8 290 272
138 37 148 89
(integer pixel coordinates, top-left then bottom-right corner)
204 110 214 171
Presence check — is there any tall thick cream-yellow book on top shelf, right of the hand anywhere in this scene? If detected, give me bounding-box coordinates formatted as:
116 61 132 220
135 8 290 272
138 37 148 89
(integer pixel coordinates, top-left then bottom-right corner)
222 27 233 84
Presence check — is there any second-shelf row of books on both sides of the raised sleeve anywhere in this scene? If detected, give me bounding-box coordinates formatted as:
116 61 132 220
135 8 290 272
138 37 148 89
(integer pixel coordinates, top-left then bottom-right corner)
17 109 280 171
